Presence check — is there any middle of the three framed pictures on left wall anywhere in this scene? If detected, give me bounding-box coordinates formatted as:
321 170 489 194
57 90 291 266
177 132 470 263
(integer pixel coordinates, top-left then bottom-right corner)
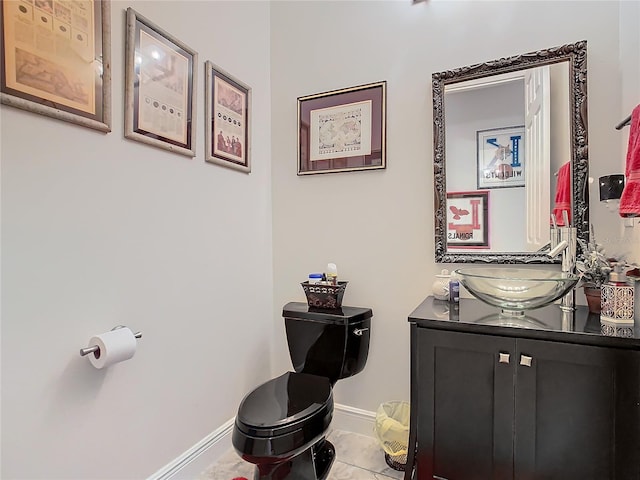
124 8 198 157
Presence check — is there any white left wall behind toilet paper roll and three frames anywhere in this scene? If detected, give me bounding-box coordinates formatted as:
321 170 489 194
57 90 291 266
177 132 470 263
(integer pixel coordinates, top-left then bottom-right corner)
0 1 273 480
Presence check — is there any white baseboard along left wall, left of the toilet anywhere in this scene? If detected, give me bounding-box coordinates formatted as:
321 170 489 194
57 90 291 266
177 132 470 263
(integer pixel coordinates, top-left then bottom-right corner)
147 417 235 480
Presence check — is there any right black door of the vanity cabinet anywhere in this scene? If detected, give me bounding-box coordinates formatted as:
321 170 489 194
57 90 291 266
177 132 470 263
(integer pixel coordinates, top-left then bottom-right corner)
514 339 640 480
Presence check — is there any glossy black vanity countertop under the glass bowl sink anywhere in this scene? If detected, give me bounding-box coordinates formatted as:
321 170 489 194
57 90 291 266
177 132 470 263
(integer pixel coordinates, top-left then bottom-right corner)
409 296 640 350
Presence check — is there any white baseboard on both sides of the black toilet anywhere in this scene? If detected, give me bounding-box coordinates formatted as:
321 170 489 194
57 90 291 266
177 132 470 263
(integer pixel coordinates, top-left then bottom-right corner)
147 403 376 480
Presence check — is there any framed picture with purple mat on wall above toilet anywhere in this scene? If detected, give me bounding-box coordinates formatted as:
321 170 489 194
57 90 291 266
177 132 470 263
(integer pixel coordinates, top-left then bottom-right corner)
298 81 387 175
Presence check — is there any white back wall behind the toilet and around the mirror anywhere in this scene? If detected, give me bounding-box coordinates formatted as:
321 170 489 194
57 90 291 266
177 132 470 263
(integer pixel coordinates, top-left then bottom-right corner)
271 0 637 410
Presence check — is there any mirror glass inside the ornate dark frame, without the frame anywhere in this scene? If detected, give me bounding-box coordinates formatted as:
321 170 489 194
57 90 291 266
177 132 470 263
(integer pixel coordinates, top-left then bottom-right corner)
444 65 571 253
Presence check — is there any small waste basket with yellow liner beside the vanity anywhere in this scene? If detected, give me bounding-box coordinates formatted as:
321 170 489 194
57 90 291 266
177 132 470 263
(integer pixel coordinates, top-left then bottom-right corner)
375 401 410 471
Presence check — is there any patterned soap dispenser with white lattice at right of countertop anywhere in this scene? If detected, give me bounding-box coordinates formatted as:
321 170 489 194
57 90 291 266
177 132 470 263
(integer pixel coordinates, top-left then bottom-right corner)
600 263 634 337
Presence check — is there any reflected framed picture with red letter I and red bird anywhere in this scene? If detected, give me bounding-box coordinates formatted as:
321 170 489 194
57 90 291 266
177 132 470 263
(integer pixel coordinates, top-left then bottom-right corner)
447 190 489 249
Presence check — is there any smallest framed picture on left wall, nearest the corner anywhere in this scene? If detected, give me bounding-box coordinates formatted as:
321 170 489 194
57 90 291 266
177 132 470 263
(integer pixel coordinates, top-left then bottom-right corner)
205 61 251 173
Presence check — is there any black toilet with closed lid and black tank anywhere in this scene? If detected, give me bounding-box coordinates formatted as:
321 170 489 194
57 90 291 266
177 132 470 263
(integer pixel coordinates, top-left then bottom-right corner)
232 302 373 480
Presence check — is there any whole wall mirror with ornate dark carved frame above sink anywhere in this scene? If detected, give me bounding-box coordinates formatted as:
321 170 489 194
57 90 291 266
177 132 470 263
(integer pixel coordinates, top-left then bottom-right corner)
432 41 589 263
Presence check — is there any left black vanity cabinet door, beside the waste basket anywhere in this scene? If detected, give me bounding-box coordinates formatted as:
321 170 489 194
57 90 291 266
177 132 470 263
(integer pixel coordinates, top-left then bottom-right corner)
412 328 515 480
